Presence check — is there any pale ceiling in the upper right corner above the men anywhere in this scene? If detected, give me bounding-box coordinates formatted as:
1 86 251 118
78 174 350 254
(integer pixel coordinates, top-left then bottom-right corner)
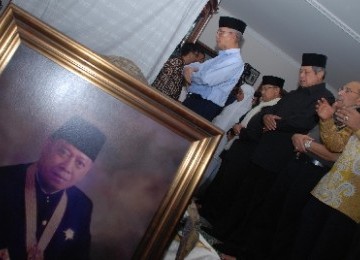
220 0 360 88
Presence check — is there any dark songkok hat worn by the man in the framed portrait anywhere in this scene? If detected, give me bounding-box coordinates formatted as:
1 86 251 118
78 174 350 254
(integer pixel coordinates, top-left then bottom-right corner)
51 117 106 161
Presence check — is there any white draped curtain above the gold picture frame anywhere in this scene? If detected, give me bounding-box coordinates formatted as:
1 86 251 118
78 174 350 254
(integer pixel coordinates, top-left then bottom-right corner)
12 0 207 83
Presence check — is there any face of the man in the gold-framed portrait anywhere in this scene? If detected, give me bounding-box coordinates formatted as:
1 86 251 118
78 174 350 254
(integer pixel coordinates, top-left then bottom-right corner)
38 139 93 193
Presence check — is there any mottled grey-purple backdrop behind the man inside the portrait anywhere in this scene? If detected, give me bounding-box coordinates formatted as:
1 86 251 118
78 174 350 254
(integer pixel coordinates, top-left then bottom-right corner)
0 45 190 259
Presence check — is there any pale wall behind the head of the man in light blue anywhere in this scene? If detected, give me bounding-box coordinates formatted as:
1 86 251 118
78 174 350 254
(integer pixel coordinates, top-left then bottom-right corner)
199 7 320 91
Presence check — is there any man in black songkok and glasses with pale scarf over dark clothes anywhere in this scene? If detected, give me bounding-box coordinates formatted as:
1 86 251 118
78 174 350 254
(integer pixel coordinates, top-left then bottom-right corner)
200 75 285 225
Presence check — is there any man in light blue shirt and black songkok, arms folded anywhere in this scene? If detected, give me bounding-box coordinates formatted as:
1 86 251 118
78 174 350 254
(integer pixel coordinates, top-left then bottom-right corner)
183 16 246 121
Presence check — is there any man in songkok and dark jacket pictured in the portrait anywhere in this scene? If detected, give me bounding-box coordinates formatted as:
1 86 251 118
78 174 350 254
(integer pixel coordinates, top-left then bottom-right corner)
0 117 105 259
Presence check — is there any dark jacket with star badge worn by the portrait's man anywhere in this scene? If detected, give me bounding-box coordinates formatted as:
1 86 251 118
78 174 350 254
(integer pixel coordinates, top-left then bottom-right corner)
0 164 92 260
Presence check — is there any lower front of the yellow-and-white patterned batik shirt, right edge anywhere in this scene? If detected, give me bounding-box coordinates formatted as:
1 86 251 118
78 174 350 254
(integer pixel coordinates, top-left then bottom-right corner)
311 130 360 223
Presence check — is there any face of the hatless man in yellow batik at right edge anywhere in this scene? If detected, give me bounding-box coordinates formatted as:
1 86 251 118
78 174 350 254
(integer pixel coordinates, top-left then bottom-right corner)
336 81 360 107
